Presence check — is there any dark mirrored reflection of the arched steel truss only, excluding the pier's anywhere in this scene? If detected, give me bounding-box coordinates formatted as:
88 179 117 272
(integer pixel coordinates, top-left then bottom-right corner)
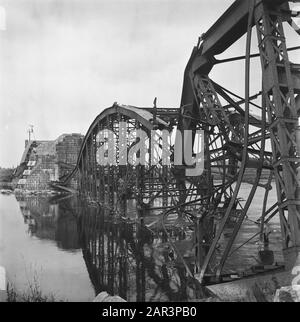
78 204 206 301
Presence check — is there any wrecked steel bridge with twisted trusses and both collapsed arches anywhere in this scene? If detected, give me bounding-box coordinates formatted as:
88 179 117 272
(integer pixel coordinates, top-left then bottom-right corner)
55 0 300 283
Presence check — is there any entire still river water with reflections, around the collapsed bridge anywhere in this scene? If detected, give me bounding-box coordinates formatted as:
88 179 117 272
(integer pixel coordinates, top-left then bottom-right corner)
0 185 282 301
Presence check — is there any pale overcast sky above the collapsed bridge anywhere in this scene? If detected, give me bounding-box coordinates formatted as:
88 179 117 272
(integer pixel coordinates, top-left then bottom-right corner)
0 0 296 167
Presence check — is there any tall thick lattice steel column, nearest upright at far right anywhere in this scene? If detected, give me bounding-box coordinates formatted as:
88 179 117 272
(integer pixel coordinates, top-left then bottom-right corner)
255 1 300 266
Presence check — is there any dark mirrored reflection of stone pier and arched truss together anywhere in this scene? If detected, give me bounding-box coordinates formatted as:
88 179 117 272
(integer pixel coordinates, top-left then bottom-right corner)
17 196 202 301
